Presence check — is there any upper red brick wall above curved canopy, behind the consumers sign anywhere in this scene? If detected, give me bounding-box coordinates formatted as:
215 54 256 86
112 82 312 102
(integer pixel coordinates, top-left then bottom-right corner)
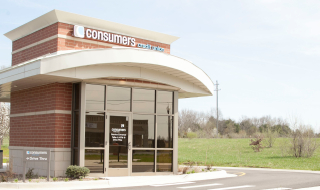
12 23 170 66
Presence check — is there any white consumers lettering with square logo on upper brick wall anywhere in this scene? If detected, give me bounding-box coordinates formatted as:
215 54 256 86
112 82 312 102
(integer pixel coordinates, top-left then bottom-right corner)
73 25 136 46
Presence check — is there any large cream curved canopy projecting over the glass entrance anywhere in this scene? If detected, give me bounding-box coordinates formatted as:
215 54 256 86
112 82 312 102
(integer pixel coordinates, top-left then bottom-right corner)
0 48 213 101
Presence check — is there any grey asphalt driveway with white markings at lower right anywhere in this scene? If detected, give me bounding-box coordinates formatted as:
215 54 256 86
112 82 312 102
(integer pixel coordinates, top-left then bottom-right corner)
88 168 320 190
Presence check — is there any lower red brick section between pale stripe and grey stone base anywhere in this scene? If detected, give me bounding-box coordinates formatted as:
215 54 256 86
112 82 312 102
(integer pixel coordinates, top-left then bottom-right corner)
10 114 71 148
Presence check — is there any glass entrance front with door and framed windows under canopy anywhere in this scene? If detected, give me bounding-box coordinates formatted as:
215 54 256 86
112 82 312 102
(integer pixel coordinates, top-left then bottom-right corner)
72 83 177 176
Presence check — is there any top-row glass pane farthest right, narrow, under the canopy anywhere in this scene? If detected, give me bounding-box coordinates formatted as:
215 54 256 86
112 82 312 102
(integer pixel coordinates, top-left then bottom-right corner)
157 91 173 114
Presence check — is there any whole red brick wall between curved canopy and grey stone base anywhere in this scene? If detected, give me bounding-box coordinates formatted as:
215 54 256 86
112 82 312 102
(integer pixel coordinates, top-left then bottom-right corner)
10 83 72 148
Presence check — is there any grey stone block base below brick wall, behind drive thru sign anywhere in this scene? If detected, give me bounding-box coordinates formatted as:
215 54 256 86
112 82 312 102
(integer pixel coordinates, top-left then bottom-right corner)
9 146 71 177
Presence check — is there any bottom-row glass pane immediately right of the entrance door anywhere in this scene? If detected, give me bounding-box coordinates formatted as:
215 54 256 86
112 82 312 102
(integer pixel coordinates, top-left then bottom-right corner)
132 150 154 172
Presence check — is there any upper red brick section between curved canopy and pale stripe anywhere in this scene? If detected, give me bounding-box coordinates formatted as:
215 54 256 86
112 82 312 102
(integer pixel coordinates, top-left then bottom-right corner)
11 83 72 114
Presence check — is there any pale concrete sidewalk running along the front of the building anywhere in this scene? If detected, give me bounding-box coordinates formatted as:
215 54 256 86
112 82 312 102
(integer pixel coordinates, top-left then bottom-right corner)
0 170 236 190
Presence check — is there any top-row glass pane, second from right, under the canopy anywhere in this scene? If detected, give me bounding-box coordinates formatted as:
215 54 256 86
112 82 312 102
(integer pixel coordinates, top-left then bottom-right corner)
132 89 155 113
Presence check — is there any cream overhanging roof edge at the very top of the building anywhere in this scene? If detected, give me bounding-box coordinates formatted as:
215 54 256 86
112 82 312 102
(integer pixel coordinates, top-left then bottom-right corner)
4 9 179 44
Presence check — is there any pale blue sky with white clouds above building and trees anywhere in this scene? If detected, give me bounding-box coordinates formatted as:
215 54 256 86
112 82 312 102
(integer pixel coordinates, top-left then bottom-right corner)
0 0 320 130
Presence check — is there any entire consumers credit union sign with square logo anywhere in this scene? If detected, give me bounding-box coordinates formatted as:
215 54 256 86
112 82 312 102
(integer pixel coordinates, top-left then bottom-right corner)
73 25 164 52
